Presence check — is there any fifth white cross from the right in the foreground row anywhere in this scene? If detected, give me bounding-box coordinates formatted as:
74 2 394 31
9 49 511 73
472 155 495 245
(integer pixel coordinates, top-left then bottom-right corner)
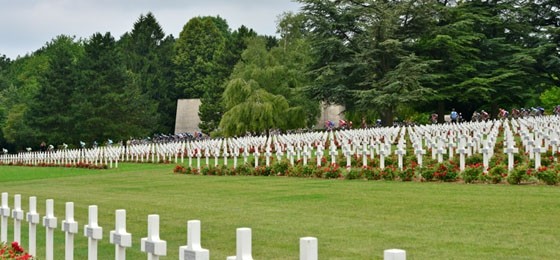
140 214 167 260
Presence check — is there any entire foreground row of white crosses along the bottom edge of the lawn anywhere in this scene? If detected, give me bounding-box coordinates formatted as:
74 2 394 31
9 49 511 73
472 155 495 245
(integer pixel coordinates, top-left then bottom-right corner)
5 192 406 260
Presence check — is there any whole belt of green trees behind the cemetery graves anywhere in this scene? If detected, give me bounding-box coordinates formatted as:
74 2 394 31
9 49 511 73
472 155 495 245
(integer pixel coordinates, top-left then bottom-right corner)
0 0 560 151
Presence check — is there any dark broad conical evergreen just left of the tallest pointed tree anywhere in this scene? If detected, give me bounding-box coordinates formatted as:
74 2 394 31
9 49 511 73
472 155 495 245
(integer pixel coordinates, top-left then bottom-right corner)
72 33 157 142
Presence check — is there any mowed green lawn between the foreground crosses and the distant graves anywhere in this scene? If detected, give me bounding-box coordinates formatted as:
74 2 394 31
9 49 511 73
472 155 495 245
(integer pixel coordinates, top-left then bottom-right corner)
0 164 560 259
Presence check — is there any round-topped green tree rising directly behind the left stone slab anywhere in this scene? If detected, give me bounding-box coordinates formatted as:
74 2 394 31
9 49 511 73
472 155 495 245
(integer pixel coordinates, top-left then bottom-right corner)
174 17 231 133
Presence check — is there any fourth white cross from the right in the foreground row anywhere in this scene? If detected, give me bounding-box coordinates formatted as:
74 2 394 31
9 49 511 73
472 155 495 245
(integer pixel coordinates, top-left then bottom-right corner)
179 220 210 260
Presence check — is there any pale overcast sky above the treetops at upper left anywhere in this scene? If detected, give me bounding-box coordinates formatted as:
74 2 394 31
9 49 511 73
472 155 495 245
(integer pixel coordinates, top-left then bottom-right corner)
0 0 300 59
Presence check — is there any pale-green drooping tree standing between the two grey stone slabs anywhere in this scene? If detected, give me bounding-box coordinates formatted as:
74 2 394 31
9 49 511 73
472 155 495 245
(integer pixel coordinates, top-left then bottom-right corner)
220 32 318 135
